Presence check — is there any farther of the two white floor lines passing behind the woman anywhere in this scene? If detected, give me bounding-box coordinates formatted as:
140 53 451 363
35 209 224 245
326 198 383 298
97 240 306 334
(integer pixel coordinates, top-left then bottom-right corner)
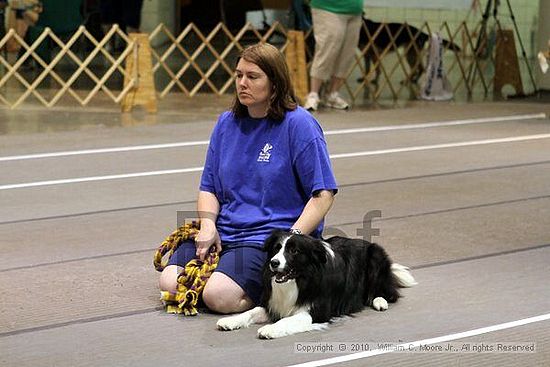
0 113 546 162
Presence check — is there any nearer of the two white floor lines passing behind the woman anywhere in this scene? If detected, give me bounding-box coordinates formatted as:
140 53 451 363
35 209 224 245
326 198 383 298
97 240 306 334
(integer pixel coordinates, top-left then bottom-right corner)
0 134 550 190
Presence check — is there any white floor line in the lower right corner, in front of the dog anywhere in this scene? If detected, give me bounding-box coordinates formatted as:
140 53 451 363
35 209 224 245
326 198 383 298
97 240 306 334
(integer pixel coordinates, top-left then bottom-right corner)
287 313 550 367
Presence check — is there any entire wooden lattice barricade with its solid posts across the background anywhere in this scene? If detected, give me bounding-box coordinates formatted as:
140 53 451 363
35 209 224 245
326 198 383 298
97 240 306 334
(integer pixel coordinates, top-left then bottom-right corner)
0 22 536 112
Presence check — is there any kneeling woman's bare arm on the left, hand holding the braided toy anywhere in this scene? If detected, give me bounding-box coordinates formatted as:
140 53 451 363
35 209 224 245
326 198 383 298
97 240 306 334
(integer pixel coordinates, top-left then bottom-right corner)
195 191 222 260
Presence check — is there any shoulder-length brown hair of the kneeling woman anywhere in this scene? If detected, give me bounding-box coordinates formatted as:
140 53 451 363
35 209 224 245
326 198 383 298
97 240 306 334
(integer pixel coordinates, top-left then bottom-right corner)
231 43 298 121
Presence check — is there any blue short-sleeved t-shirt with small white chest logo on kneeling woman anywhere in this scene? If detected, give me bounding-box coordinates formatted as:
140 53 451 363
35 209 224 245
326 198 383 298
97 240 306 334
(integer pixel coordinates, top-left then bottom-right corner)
200 107 337 244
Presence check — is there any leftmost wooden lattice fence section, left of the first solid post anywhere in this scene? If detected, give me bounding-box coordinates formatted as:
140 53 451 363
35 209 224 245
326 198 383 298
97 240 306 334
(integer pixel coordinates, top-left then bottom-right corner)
0 25 137 108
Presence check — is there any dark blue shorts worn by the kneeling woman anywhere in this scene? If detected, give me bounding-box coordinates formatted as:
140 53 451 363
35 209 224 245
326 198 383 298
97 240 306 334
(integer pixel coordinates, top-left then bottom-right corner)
168 242 267 304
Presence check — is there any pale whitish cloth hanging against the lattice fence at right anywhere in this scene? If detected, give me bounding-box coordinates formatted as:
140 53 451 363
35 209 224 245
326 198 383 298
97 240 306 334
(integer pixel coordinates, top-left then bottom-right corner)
420 33 453 101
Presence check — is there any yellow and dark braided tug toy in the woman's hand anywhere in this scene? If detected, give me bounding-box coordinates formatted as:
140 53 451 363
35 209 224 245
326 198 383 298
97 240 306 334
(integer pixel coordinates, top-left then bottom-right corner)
153 222 219 316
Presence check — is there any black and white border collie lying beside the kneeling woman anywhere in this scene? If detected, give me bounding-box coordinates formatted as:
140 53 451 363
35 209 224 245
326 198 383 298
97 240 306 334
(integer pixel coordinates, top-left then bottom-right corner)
217 231 416 339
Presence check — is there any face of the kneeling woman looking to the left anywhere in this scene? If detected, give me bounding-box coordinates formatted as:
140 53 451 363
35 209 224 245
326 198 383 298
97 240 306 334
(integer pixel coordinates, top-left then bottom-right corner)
235 59 271 118
